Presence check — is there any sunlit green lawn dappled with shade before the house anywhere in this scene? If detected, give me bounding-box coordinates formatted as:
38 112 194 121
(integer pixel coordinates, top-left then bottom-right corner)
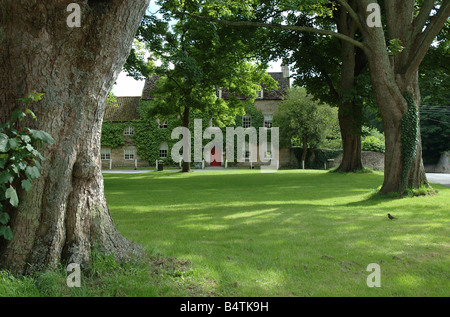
101 170 450 296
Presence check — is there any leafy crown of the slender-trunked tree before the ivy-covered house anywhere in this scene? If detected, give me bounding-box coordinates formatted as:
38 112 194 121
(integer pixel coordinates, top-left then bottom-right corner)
138 5 277 172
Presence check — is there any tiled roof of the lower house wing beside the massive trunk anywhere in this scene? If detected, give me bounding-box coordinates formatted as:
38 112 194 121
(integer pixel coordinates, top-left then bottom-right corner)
104 97 141 122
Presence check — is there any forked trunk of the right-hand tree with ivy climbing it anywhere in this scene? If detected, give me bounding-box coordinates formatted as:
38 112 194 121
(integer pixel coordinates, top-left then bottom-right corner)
359 0 444 194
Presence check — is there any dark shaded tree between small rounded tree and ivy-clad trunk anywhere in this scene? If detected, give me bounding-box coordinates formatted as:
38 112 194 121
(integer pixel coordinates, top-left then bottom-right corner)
253 7 373 172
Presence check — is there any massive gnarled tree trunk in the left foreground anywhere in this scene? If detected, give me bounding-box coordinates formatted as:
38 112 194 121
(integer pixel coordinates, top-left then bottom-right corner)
0 0 149 274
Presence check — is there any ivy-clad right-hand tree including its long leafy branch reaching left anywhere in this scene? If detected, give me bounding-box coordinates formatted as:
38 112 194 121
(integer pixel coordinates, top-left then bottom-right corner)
169 0 450 194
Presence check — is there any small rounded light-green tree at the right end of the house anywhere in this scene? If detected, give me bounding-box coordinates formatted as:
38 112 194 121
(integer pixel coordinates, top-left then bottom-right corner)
274 88 338 166
